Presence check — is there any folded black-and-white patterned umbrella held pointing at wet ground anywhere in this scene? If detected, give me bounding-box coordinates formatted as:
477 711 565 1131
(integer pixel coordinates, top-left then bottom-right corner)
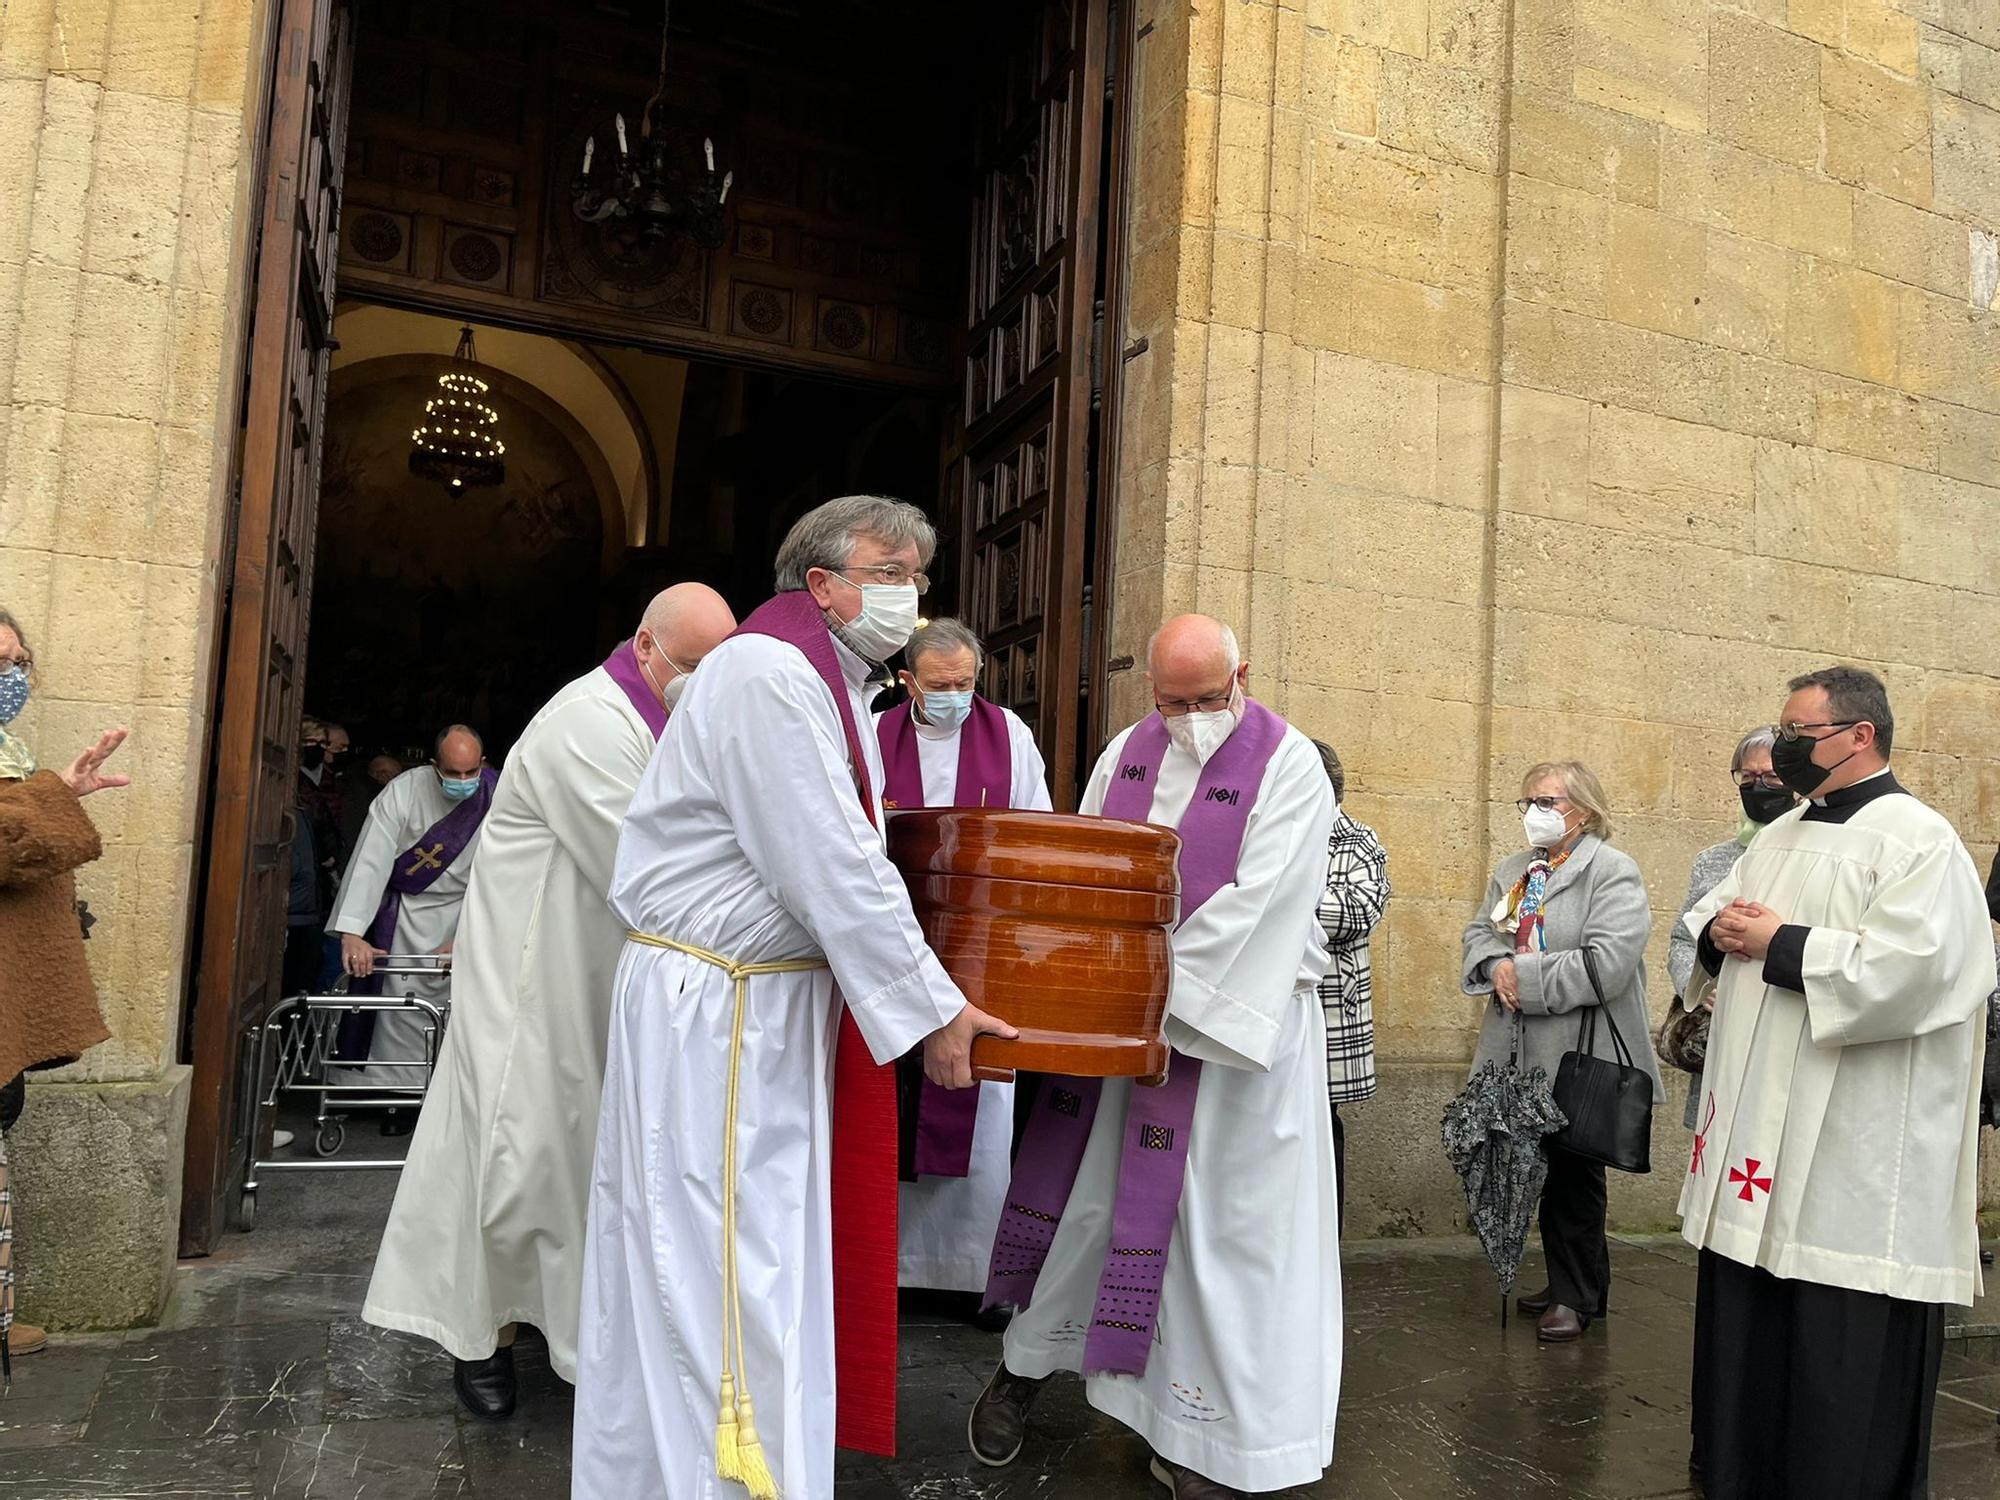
1440 1016 1568 1326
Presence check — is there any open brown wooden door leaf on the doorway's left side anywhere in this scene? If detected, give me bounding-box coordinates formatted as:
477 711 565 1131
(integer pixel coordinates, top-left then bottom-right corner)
180 0 352 1256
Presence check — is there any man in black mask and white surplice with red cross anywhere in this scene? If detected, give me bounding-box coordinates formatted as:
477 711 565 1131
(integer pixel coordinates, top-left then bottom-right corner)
1680 666 1992 1500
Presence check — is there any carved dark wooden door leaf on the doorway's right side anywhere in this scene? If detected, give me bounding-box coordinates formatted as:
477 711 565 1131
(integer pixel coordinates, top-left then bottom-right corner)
948 0 1110 806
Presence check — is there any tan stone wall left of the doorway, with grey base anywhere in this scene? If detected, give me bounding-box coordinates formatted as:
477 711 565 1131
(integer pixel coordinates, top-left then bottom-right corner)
0 0 260 1324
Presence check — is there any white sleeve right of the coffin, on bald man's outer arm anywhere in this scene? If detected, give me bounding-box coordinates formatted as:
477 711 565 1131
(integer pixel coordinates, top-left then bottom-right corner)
1166 736 1334 1072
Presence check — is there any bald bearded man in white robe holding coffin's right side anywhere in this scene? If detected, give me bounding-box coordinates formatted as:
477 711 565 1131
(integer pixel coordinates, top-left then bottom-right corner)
970 616 1340 1500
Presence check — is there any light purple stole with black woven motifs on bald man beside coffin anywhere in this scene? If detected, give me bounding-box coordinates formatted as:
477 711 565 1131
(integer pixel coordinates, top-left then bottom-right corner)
986 700 1286 1374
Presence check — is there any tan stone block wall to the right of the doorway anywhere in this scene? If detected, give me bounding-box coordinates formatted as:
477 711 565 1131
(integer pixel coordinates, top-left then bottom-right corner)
1112 0 2000 1234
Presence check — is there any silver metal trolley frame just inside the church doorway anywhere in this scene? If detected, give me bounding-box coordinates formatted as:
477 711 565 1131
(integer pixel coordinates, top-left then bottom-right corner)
236 954 452 1234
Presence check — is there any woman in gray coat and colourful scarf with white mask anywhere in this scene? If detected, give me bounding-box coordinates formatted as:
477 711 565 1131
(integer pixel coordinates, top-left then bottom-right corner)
1464 760 1664 1344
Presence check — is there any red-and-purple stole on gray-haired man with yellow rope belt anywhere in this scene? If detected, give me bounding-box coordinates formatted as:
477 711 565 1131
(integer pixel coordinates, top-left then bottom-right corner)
736 590 896 1458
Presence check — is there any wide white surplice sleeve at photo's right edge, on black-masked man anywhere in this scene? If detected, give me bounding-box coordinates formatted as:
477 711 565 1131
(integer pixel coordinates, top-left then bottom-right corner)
1800 838 1992 1046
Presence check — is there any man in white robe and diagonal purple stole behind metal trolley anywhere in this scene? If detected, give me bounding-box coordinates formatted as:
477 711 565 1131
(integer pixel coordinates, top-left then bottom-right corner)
326 724 490 1136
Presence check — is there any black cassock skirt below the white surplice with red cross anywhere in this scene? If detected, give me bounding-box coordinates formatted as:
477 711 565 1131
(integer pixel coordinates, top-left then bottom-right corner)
1694 1250 1944 1500
